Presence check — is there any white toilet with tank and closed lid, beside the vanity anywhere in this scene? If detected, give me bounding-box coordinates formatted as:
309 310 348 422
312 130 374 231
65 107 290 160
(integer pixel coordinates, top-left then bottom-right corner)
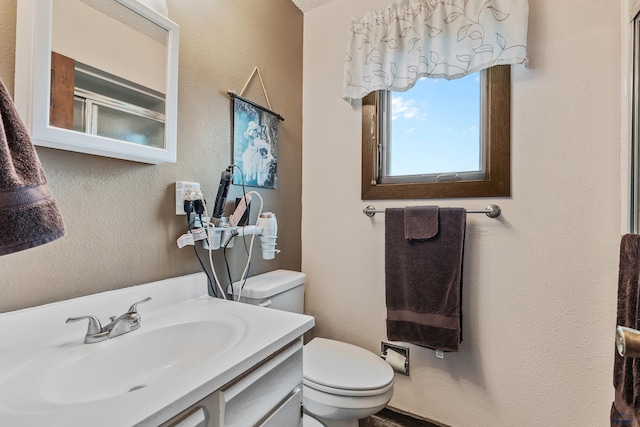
233 270 393 427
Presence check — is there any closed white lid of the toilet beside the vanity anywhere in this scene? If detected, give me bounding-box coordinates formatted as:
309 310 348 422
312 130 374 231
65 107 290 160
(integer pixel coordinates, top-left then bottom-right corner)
303 338 393 391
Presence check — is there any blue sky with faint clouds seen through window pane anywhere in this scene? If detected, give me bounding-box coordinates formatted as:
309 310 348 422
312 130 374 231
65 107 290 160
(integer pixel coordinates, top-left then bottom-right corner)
388 73 481 176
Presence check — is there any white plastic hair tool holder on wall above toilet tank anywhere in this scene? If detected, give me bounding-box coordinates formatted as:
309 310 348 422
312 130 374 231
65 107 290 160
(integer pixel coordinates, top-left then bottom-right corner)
202 212 280 259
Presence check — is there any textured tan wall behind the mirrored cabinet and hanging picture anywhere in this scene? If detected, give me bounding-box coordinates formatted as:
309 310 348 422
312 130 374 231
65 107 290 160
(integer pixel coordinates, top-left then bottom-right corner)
0 0 303 312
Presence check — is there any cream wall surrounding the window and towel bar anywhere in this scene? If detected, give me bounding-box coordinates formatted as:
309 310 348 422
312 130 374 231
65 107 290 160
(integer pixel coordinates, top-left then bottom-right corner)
302 0 620 427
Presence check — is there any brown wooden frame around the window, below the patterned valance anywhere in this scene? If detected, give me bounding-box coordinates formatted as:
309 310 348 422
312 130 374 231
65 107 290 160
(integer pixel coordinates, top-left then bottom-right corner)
362 65 511 200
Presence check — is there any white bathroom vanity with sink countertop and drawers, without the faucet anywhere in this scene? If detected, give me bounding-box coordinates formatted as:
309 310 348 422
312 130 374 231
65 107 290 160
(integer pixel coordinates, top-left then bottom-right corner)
0 273 314 427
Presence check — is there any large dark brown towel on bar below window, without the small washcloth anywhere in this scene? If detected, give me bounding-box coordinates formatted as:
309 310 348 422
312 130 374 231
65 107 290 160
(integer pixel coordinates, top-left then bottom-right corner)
385 208 467 351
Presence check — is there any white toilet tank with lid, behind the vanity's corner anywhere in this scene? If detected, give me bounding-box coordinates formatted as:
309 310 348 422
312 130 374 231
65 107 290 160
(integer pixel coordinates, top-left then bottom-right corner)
233 270 307 313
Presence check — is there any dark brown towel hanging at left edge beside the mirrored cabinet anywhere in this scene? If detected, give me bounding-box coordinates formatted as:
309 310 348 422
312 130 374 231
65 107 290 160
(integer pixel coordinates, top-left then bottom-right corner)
0 78 65 255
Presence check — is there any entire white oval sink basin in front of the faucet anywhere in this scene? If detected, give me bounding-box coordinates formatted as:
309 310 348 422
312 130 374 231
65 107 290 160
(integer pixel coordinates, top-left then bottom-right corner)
0 320 246 410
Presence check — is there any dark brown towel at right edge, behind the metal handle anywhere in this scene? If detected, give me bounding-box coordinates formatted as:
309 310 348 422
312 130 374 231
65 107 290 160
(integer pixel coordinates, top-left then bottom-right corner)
611 234 640 427
